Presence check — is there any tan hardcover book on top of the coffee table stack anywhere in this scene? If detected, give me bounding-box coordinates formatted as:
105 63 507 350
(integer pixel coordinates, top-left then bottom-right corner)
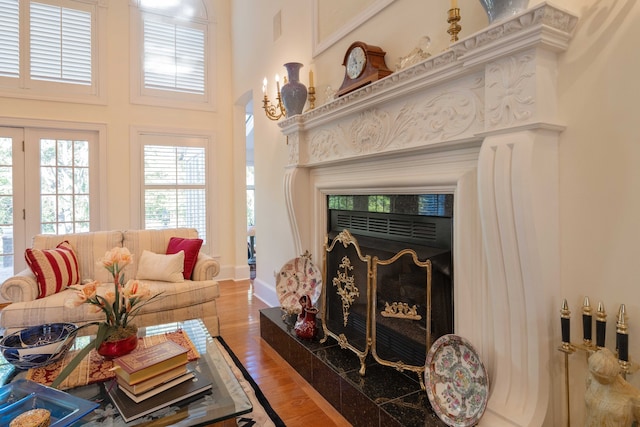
113 341 188 385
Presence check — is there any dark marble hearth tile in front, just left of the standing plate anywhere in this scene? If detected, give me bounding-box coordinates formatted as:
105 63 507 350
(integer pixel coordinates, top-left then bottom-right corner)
380 390 446 427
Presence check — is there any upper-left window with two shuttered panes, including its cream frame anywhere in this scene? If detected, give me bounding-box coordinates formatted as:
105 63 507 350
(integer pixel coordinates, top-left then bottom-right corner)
0 0 104 102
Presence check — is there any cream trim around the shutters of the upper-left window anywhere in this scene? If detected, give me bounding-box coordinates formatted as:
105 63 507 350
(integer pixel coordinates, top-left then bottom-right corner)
0 0 107 105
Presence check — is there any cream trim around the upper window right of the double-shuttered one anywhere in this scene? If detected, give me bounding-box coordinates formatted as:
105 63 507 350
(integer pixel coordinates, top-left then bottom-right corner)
129 0 217 111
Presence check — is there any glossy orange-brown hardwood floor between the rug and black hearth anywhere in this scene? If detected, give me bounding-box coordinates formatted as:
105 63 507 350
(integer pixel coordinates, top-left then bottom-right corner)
217 280 351 427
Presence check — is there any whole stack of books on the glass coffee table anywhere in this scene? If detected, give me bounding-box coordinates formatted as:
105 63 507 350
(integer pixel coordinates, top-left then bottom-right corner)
109 341 212 422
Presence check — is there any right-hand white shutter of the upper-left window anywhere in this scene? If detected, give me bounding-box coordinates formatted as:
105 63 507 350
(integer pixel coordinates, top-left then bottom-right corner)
30 2 91 85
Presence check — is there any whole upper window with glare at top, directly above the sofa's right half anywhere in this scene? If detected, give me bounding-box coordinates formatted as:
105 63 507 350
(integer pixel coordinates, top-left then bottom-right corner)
131 0 213 109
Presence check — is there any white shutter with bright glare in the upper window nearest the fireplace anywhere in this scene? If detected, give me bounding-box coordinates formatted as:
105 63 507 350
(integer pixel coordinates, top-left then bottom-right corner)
143 15 205 95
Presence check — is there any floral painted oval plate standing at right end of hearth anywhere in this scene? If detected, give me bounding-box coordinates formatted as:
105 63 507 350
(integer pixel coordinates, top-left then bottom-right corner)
424 334 489 427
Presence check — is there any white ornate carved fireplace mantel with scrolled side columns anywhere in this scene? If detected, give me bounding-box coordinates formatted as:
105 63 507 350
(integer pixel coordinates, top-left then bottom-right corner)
280 3 577 427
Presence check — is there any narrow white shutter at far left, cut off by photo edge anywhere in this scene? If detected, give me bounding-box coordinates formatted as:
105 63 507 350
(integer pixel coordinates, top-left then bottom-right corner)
0 0 20 78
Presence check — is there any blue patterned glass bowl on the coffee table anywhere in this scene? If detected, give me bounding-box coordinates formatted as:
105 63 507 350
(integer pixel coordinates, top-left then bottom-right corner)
0 323 78 369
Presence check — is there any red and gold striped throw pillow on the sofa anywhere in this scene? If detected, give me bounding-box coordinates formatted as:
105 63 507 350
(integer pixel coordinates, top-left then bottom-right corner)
24 240 80 298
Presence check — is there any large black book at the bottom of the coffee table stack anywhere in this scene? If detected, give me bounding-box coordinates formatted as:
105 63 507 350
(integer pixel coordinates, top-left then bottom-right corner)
108 370 212 422
